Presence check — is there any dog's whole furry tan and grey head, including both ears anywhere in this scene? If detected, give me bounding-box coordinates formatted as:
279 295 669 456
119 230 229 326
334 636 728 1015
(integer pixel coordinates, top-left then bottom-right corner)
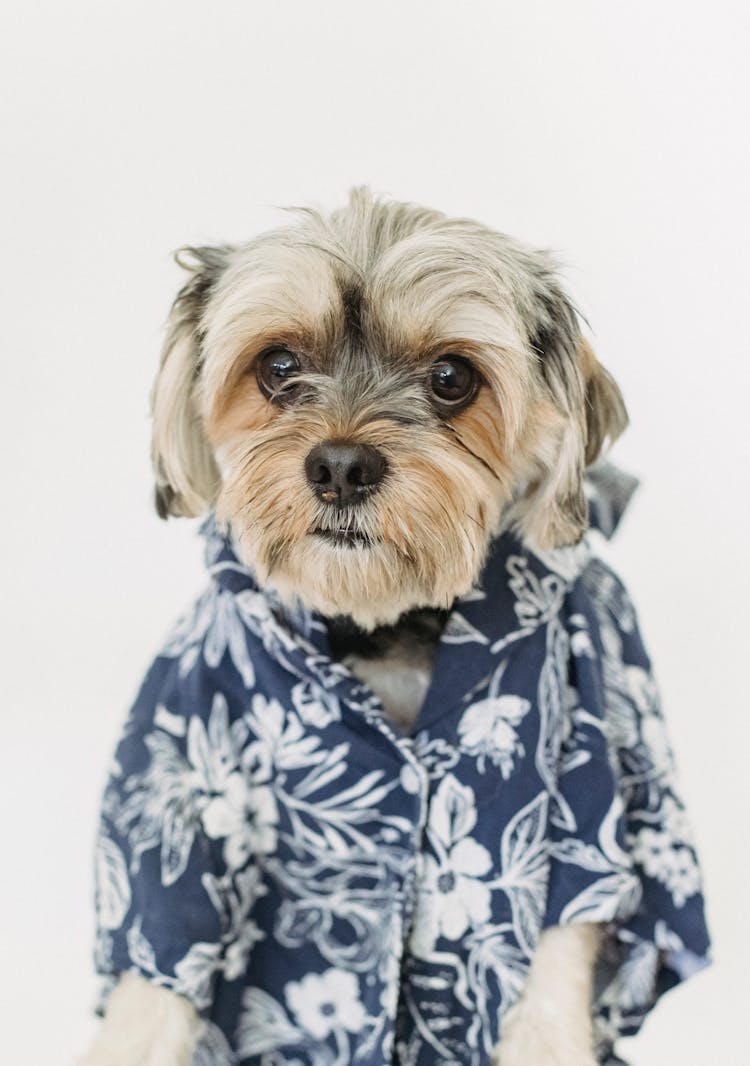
153 190 626 627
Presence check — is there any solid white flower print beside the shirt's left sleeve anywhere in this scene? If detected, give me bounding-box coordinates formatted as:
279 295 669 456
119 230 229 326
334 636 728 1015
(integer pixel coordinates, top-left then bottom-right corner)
202 773 278 870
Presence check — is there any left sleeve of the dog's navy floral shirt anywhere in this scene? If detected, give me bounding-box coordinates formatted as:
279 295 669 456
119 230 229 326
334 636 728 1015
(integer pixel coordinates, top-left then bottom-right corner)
96 659 235 1011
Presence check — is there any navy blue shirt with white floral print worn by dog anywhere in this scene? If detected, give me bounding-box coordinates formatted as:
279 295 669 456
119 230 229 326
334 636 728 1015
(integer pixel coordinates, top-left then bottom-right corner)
96 469 708 1066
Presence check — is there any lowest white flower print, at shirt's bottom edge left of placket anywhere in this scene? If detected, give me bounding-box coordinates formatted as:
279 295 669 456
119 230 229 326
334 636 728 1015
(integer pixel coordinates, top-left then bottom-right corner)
284 969 368 1040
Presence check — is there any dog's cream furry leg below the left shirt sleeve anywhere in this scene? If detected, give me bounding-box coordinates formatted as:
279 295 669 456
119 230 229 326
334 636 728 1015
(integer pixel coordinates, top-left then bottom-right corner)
77 973 202 1066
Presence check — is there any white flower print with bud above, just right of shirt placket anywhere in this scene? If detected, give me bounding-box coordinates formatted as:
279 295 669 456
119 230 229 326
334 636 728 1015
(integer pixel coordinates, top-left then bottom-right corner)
411 774 492 958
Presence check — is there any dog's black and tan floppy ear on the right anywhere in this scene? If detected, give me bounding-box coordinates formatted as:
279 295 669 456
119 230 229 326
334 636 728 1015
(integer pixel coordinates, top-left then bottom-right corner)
517 276 627 549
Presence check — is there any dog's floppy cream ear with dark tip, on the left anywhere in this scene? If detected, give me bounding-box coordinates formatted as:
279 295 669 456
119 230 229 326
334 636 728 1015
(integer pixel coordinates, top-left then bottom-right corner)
151 246 231 518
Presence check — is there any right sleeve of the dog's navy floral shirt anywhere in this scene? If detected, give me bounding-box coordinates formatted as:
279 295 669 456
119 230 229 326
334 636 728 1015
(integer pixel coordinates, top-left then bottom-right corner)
547 560 710 1047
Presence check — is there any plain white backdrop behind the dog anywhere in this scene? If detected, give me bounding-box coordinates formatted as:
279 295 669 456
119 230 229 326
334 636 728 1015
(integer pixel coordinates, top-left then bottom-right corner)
0 0 750 1066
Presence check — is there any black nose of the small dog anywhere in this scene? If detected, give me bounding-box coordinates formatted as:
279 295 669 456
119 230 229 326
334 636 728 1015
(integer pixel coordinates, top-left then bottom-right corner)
305 440 386 507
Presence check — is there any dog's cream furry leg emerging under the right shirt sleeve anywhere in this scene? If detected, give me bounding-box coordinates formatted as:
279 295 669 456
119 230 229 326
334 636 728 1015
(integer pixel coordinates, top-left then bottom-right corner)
495 923 602 1066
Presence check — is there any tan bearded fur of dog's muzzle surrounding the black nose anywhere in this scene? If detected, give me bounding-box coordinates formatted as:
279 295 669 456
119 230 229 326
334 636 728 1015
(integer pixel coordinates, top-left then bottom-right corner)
212 401 501 628
